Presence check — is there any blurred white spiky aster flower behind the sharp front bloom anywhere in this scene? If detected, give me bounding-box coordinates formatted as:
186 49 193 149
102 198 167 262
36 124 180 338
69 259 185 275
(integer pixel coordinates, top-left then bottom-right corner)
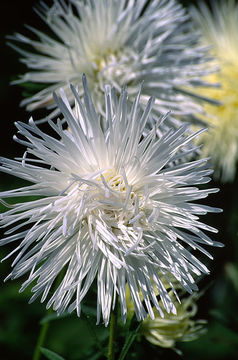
10 0 214 126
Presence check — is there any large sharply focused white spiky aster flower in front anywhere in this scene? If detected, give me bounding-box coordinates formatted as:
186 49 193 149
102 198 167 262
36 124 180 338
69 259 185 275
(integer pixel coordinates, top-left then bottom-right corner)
0 78 220 324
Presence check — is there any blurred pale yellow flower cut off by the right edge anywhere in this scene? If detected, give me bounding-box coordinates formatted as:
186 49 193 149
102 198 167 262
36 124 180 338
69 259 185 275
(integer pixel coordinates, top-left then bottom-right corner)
192 0 238 182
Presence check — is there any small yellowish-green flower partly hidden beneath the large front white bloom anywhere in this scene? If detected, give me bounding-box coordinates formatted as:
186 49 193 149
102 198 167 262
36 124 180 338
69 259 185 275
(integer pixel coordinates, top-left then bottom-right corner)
126 274 206 353
